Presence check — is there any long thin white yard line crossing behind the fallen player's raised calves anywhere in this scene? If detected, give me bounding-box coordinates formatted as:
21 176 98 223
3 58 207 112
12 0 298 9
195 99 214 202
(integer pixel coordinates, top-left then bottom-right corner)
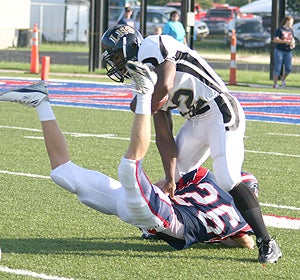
0 125 300 158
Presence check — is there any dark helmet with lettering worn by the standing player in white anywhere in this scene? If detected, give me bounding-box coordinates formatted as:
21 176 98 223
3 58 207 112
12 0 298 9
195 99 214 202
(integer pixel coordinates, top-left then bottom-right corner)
101 25 143 82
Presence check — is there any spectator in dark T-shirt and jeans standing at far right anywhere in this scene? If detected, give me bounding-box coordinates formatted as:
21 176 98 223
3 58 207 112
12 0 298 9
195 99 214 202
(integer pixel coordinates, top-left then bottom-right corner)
273 16 295 88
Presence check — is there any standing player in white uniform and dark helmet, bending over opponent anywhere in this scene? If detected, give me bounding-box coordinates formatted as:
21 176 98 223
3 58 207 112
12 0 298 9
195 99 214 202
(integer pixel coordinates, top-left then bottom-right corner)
101 25 281 263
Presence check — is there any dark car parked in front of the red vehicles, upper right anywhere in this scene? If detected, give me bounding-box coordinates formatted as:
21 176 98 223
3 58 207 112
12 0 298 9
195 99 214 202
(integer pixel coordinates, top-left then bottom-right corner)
225 18 271 49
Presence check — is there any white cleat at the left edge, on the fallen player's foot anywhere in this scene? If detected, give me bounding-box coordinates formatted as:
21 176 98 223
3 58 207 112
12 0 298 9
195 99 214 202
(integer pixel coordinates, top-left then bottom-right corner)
0 82 49 107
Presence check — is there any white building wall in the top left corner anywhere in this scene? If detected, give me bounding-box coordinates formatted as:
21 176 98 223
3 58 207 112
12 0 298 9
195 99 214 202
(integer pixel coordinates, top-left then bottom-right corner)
0 0 32 49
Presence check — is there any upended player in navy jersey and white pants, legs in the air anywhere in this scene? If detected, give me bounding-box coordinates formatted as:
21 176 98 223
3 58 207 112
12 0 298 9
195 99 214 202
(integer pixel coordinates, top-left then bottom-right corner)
0 81 254 254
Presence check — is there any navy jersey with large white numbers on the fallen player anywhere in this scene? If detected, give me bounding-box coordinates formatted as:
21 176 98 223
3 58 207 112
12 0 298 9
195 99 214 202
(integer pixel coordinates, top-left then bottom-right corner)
158 168 252 249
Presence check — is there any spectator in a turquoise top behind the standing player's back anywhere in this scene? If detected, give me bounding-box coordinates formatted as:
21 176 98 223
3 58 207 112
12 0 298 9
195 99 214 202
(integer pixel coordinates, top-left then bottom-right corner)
162 11 187 45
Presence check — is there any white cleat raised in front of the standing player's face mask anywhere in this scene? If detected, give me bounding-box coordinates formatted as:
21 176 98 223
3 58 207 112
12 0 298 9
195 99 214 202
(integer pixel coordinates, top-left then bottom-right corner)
126 60 157 94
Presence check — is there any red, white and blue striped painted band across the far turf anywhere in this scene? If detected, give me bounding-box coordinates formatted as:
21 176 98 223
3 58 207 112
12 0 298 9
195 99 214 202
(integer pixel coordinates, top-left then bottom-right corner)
0 79 300 124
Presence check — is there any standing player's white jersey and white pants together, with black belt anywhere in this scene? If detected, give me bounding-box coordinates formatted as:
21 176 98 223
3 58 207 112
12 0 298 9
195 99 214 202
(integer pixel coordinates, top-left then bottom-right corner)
138 35 245 191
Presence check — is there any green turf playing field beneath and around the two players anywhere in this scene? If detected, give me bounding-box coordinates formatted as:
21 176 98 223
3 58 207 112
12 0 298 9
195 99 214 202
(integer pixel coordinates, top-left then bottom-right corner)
0 103 300 280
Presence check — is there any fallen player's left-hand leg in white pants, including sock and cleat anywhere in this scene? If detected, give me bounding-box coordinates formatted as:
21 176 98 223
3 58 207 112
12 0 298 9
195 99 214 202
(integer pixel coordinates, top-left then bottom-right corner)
0 83 130 218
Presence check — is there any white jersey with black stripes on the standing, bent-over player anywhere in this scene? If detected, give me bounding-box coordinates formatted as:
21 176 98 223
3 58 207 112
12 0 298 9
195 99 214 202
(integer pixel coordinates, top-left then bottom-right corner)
138 35 228 119
